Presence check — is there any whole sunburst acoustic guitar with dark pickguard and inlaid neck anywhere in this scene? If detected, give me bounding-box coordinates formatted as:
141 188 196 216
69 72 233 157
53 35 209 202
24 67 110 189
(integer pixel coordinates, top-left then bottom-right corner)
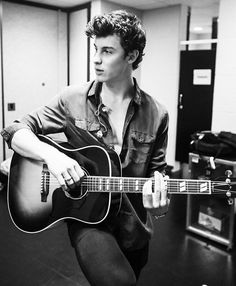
7 135 232 233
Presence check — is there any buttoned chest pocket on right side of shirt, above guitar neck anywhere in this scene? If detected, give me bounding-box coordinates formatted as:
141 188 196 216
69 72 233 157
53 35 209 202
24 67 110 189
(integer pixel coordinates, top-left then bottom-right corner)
129 131 155 164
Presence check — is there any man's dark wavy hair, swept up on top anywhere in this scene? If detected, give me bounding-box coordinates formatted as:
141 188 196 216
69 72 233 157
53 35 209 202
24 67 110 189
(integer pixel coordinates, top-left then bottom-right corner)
85 10 146 70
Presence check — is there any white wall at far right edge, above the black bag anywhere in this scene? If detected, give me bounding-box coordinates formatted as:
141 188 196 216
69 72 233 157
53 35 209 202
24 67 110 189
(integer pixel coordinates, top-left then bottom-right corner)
212 0 236 133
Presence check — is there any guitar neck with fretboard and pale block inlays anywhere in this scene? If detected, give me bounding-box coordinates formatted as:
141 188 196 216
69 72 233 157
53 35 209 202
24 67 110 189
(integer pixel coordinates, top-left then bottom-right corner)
82 176 212 194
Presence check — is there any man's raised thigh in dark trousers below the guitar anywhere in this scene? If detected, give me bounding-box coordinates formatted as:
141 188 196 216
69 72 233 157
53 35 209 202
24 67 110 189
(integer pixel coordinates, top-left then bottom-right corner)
69 224 136 286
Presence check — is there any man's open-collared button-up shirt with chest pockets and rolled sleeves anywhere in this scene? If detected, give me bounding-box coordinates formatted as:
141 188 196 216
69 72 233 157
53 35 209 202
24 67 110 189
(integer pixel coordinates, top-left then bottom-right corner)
1 79 168 248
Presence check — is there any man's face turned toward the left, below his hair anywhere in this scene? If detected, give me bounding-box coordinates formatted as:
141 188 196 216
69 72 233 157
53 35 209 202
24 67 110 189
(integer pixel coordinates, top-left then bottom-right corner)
94 35 132 82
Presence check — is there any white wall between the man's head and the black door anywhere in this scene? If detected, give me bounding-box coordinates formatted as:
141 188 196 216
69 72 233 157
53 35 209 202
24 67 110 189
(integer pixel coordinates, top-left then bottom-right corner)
141 6 187 169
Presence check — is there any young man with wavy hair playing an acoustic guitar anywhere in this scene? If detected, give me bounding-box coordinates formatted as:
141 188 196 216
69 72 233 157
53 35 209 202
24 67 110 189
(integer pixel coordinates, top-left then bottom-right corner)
2 10 169 286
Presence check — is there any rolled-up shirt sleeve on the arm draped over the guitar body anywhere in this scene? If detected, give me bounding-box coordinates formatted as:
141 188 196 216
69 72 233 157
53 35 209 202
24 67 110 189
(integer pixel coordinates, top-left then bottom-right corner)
1 93 66 148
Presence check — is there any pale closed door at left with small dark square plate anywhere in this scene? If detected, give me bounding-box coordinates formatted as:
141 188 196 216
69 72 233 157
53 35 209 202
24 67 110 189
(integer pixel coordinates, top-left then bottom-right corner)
3 2 67 157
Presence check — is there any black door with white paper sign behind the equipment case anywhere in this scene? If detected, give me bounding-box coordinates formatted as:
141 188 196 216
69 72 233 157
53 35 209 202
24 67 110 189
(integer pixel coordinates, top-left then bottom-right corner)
175 50 215 163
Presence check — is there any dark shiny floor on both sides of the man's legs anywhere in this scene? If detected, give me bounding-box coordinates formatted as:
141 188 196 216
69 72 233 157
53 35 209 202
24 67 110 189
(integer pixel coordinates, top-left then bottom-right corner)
0 183 236 286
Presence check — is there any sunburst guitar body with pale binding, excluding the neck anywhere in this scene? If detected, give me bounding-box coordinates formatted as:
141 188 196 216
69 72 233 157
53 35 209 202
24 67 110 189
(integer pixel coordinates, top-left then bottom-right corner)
8 136 121 233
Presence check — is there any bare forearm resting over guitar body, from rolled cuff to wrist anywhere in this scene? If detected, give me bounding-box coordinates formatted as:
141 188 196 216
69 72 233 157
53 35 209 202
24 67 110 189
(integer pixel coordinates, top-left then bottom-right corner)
11 128 59 161
